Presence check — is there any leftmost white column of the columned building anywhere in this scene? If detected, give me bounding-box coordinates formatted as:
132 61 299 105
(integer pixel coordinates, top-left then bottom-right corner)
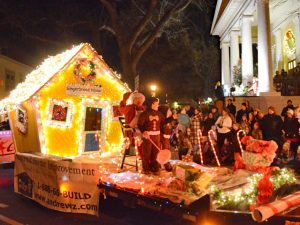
221 42 232 92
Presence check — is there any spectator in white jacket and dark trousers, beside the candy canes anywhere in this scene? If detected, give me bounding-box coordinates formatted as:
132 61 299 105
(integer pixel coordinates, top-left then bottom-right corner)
216 109 232 150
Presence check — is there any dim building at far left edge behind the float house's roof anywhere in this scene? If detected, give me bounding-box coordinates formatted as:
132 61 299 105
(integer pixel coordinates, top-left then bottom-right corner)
0 55 32 99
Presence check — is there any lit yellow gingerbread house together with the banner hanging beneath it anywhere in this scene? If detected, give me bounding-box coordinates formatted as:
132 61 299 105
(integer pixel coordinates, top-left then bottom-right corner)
0 44 129 214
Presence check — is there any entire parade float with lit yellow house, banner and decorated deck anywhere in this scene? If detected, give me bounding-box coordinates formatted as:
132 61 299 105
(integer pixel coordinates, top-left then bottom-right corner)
0 44 299 221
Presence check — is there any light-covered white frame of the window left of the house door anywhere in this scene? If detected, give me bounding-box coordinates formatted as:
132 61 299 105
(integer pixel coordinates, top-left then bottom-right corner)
46 99 73 128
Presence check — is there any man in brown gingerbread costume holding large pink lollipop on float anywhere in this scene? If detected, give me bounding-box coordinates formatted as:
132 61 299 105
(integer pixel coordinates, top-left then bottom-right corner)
138 98 164 175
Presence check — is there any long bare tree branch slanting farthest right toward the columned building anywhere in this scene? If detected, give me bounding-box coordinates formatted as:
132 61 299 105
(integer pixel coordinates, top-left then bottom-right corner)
133 0 192 64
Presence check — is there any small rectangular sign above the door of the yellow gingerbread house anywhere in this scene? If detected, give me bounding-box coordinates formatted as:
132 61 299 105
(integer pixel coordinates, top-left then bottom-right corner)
67 84 102 96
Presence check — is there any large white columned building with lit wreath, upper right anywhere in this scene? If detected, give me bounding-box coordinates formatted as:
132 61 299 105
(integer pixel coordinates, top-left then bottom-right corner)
211 0 300 95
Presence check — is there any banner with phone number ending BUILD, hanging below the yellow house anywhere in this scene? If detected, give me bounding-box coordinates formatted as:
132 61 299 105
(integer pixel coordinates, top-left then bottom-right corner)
14 153 99 215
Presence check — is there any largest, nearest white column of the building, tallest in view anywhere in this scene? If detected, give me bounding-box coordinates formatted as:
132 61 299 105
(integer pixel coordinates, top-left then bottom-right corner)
257 0 273 94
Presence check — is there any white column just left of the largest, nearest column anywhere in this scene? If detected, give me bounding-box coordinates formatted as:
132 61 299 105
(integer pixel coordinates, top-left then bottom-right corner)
241 15 253 85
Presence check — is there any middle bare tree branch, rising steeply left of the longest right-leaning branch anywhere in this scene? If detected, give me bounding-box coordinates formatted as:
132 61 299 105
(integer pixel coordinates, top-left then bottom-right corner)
128 0 157 53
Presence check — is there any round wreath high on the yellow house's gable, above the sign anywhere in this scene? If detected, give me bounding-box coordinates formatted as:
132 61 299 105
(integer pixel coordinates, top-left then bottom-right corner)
74 58 96 84
